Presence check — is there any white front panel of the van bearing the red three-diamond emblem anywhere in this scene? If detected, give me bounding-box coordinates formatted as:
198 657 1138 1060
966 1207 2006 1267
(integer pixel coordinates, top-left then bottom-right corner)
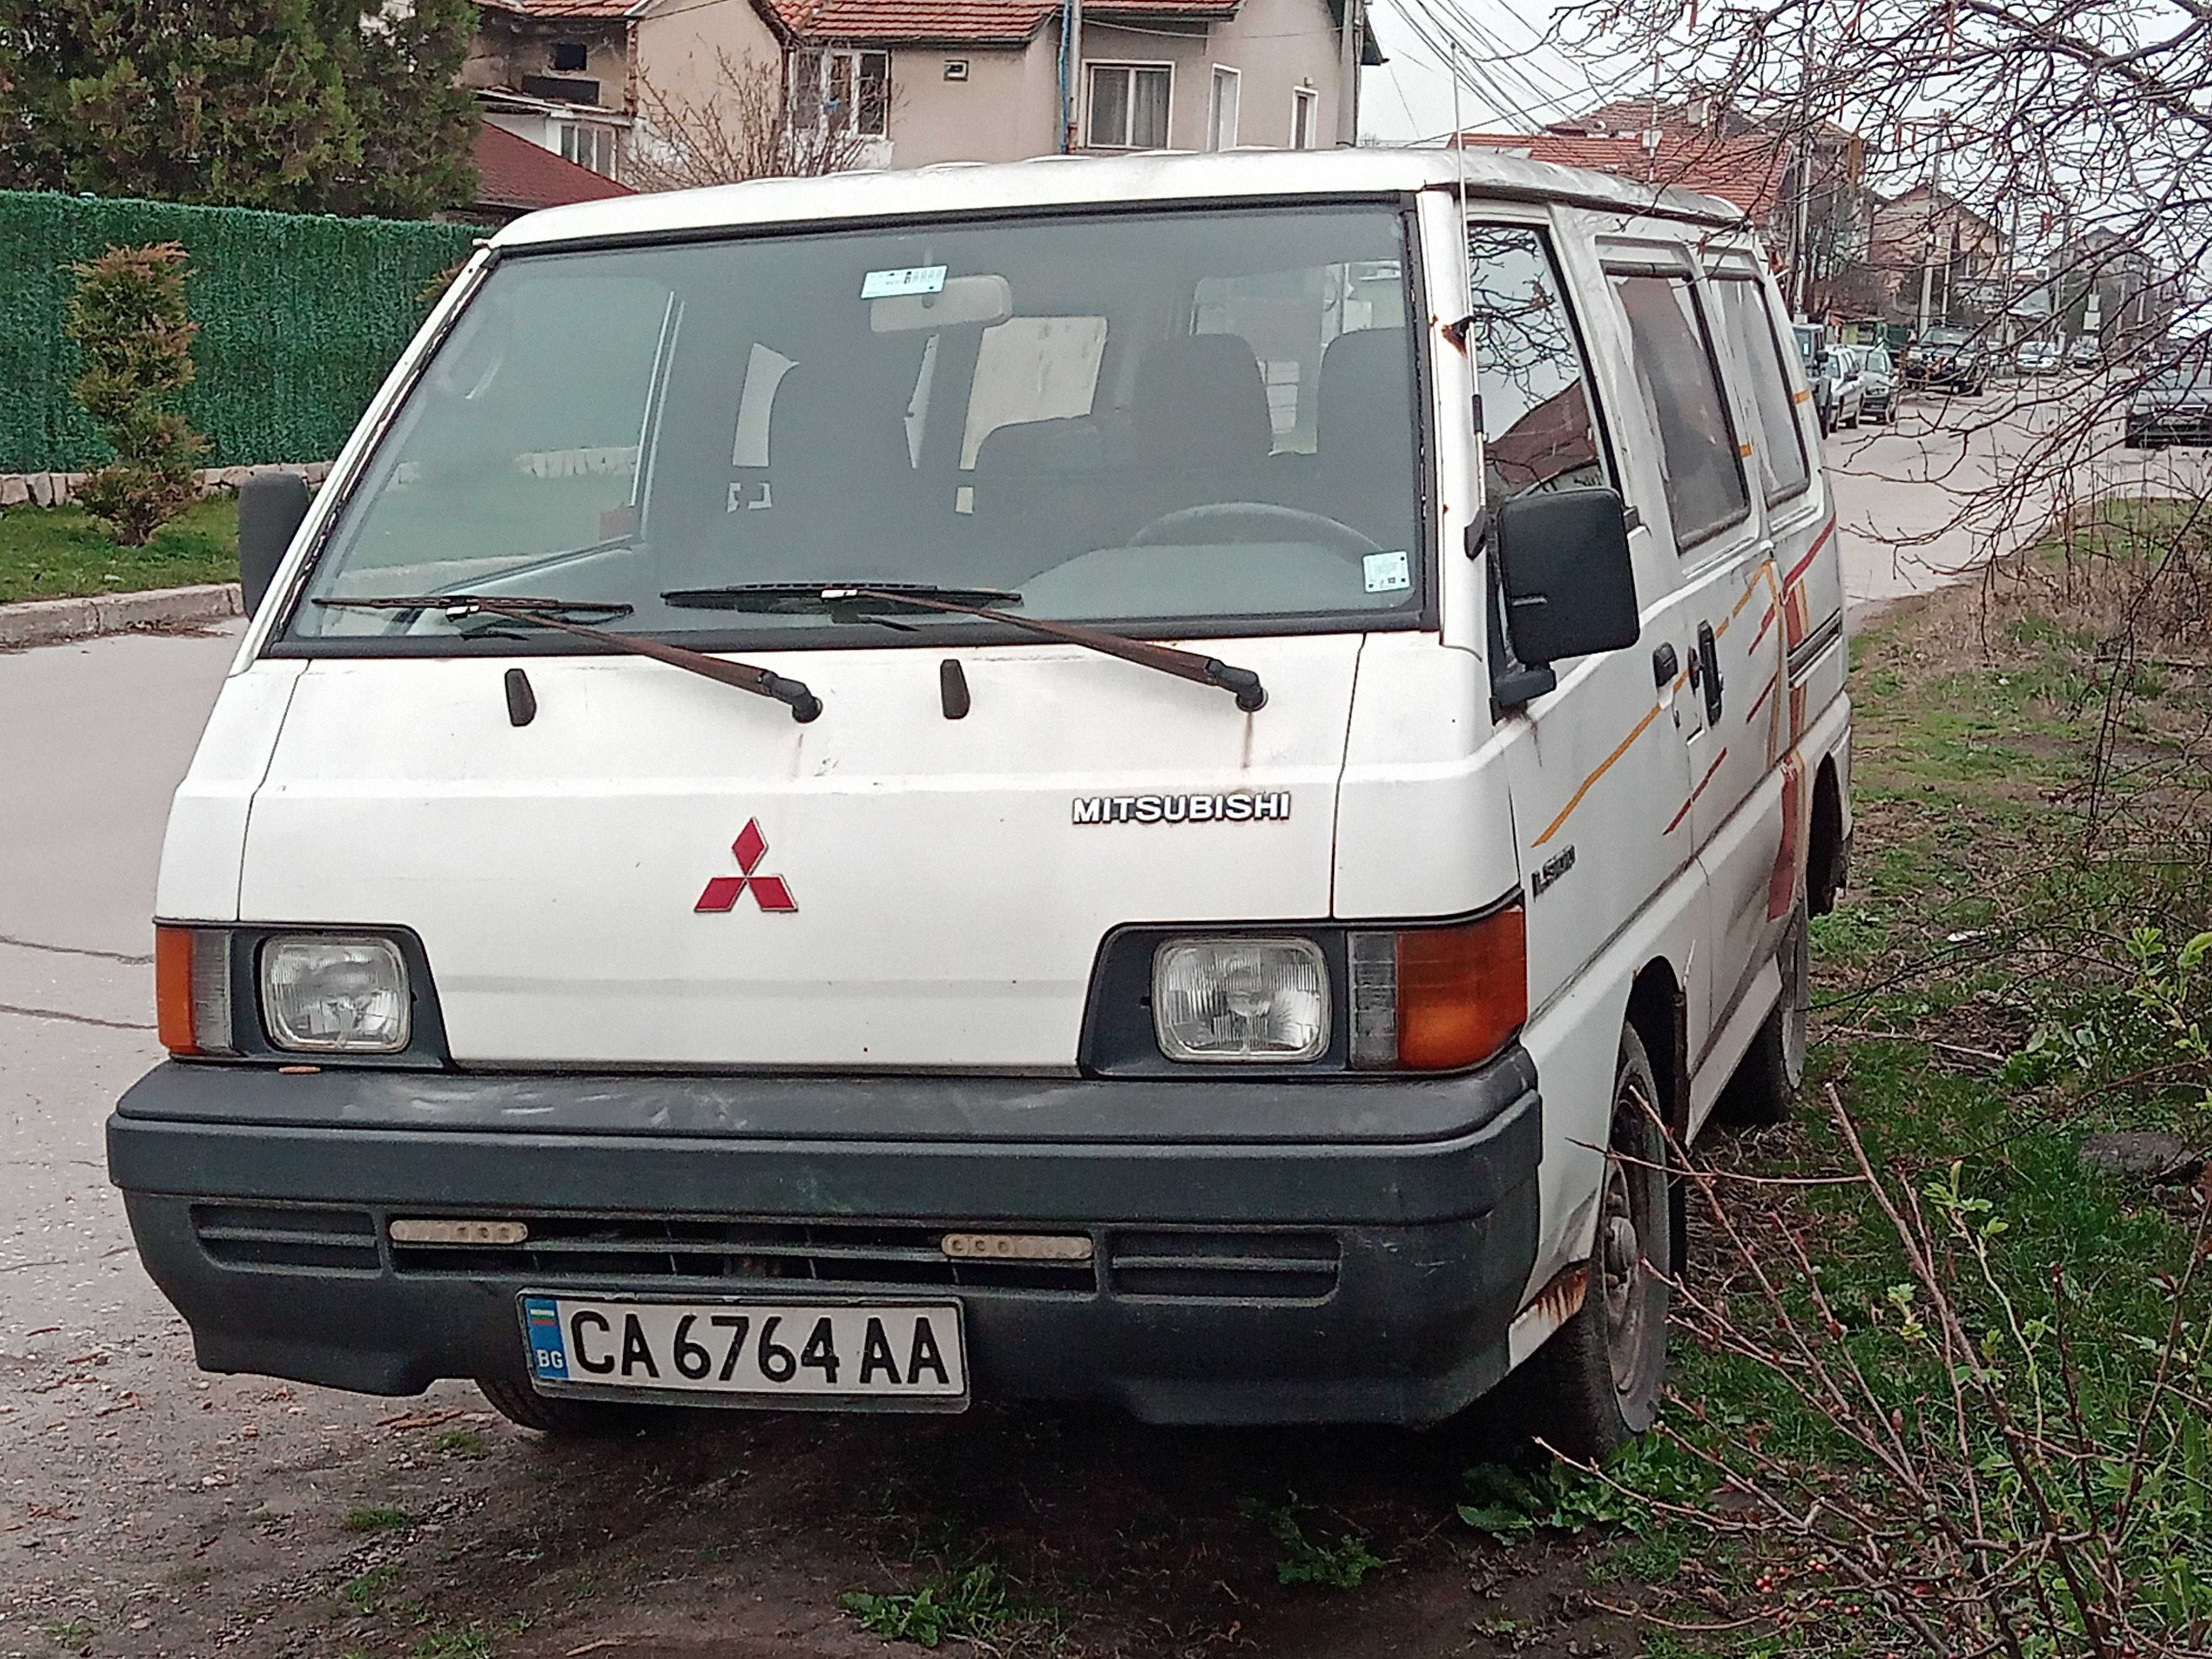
239 635 1360 1070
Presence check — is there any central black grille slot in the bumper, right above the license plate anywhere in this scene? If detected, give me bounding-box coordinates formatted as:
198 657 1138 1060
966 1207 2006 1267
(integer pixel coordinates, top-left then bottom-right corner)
392 1212 1097 1296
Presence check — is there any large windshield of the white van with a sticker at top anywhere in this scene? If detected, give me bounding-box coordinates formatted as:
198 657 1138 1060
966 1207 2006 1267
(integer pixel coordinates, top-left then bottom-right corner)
290 206 1422 648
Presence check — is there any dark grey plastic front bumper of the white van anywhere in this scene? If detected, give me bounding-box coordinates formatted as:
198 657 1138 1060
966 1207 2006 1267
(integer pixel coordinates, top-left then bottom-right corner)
109 1046 1542 1422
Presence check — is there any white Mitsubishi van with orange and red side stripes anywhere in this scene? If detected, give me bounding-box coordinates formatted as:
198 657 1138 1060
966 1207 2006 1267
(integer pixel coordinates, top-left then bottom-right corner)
109 151 1851 1449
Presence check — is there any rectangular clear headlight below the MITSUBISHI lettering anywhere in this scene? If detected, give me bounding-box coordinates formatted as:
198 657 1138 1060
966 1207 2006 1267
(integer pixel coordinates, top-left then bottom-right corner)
1152 938 1330 1064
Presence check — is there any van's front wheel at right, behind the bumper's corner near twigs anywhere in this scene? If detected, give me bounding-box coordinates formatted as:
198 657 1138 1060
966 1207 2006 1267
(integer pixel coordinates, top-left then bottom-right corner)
1522 1029 1675 1462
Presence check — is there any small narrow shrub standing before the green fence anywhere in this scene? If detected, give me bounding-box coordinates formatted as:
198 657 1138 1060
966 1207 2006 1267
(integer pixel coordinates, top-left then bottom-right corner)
66 241 208 547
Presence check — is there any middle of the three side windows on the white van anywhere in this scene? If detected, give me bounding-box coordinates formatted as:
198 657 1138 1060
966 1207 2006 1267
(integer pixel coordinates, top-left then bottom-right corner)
1613 272 1752 553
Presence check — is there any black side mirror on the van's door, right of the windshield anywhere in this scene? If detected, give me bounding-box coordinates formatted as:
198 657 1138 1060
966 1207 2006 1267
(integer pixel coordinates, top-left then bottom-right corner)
1493 489 1643 694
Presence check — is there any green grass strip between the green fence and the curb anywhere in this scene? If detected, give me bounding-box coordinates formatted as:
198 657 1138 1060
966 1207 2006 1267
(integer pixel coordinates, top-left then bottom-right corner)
0 496 239 604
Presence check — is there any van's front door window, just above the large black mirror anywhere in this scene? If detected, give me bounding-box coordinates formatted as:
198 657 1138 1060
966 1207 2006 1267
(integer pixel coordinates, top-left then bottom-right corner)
1467 226 1608 502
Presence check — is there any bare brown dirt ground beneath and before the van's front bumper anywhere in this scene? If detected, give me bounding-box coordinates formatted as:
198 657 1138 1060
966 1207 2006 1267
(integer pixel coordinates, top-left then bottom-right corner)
0 1320 1637 1659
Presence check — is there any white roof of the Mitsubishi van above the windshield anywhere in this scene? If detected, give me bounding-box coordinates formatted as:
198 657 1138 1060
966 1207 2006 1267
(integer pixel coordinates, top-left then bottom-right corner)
491 148 1748 248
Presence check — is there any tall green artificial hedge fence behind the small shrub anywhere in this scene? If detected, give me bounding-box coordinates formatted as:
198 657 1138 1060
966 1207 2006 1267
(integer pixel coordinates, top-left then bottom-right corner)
0 190 482 474
